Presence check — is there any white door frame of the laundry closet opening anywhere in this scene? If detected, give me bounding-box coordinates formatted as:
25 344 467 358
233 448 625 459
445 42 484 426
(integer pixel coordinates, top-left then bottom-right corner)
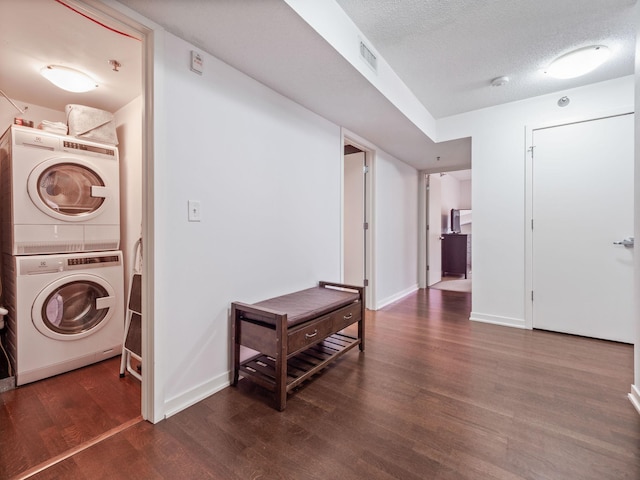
80 0 157 423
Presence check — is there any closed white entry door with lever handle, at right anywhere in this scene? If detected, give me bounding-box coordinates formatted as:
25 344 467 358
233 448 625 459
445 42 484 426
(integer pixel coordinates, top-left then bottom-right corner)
532 114 634 343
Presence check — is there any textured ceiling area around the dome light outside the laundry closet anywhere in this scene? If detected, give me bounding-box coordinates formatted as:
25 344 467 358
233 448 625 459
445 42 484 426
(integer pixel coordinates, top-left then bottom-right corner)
337 0 636 118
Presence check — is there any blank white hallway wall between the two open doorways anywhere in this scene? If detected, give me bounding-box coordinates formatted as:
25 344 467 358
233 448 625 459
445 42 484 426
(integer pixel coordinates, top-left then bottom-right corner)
373 151 418 308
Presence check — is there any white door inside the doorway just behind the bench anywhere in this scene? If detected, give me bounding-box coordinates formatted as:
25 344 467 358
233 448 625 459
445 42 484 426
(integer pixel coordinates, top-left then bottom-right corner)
343 152 366 285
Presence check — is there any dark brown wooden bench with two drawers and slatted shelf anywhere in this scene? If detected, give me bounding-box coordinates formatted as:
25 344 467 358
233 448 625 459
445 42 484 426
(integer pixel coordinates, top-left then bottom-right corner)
231 282 365 411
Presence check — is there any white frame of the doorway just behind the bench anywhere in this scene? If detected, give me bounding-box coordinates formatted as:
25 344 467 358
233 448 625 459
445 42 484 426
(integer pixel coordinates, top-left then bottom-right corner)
340 128 376 310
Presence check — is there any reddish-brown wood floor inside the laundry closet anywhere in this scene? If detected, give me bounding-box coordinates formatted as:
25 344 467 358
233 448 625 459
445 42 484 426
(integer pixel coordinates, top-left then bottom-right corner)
0 357 140 479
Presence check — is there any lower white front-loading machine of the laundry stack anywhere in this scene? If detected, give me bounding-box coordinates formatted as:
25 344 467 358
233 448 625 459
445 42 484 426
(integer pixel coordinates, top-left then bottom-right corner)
3 251 125 385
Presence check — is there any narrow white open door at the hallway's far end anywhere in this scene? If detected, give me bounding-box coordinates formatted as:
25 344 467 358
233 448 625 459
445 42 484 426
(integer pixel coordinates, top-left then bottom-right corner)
427 174 442 287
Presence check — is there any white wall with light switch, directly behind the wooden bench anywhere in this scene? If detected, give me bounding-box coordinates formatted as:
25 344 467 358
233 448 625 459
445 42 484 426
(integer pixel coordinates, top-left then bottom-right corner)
154 33 342 414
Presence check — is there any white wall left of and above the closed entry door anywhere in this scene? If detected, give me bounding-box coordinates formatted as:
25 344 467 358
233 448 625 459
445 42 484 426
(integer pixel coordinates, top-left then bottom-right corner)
438 76 634 326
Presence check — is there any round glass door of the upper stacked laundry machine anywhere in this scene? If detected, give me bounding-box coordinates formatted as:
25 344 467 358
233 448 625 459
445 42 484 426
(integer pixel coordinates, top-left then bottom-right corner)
27 158 112 222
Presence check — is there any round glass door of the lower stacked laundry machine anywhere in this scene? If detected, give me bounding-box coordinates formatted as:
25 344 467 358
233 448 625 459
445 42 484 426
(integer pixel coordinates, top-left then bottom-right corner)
31 274 117 340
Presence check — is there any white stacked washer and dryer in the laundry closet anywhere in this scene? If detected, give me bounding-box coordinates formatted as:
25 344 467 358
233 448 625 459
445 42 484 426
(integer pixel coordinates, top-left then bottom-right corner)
0 125 124 385
